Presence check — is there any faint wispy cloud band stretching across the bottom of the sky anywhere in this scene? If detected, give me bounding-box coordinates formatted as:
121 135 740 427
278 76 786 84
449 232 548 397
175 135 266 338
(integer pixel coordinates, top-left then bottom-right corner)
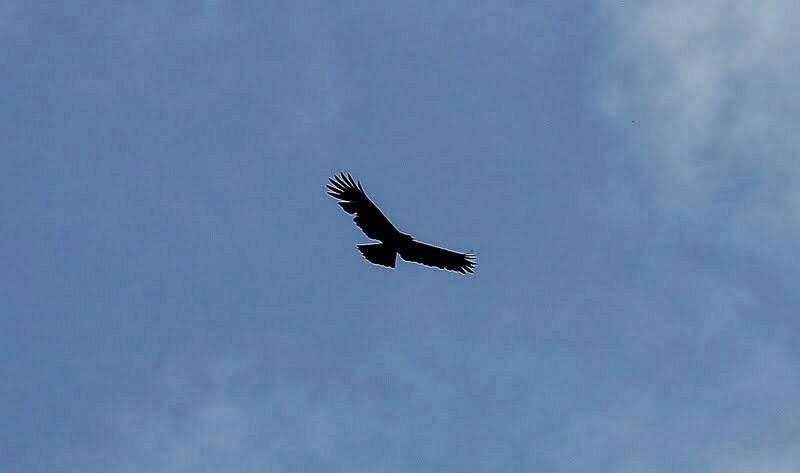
52 272 784 472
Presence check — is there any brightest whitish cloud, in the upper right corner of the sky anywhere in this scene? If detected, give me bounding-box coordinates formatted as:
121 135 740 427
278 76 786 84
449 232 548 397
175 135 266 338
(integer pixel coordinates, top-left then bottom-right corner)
600 0 800 256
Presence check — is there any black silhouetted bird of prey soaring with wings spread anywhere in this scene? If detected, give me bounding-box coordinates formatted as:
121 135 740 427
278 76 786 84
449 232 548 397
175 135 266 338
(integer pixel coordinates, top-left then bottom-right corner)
326 172 477 274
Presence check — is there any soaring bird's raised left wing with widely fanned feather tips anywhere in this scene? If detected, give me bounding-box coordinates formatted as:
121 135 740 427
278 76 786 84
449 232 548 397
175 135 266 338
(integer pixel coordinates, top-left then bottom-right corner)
327 173 398 240
